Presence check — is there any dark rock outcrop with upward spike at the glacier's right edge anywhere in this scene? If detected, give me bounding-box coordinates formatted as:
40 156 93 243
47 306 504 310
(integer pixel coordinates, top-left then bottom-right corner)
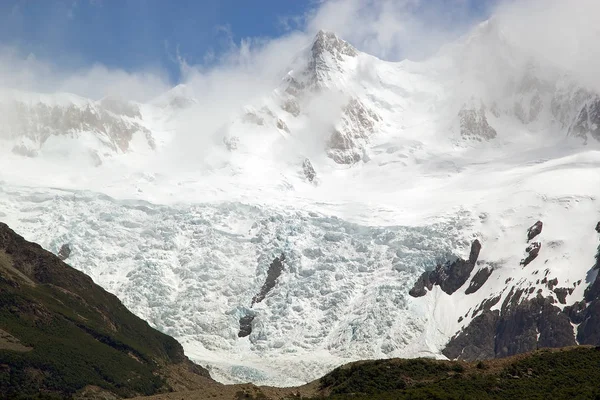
409 239 481 297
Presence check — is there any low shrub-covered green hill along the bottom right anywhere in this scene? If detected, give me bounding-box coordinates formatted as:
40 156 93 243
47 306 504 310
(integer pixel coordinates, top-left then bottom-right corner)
320 347 600 400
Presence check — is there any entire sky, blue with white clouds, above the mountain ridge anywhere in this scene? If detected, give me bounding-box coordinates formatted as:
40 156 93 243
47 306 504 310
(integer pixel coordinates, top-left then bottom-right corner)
0 0 600 104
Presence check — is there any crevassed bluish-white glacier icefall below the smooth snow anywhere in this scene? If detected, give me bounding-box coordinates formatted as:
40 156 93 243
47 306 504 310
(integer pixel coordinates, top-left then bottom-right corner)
0 186 469 385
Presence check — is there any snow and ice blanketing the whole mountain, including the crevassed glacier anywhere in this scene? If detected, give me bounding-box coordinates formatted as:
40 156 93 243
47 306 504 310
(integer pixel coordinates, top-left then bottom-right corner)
0 18 600 386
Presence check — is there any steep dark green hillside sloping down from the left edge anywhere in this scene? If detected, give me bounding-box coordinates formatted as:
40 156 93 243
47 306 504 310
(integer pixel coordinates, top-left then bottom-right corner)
0 223 208 398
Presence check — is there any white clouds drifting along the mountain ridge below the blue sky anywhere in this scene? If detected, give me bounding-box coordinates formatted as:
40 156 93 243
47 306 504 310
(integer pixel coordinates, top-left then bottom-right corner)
0 0 600 111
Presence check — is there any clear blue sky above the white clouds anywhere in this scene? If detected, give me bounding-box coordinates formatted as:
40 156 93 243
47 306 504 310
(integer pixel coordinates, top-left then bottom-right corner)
0 0 497 84
